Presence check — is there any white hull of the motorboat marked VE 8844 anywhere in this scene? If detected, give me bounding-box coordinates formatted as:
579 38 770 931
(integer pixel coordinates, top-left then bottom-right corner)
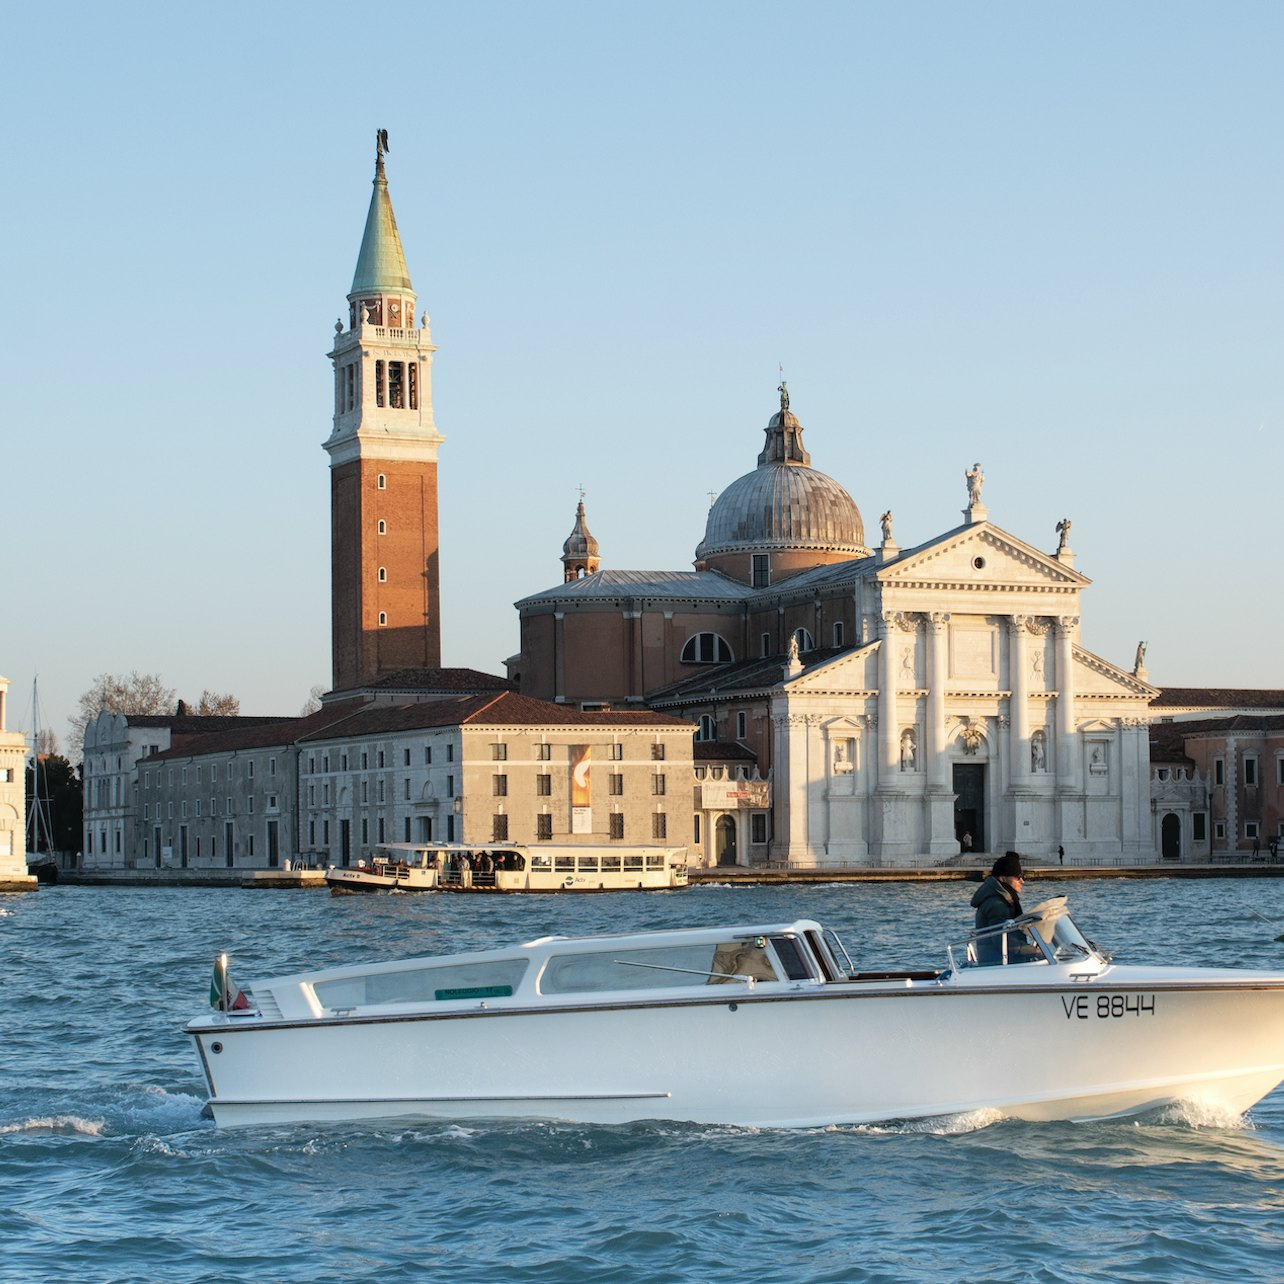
189 969 1284 1127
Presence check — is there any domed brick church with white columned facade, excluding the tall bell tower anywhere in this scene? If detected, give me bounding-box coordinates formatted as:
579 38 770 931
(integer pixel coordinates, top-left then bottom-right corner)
508 385 1157 867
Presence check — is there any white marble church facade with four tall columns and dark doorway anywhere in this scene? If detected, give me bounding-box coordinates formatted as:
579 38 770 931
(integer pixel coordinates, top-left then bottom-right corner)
770 512 1156 867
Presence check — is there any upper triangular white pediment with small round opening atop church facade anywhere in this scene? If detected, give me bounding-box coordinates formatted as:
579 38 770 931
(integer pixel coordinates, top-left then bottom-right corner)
878 521 1091 592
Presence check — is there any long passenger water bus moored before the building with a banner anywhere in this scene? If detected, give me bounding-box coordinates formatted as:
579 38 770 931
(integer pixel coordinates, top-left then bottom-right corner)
325 842 687 896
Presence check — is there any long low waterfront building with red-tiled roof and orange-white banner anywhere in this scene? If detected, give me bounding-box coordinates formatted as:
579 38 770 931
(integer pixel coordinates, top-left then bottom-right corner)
137 692 698 869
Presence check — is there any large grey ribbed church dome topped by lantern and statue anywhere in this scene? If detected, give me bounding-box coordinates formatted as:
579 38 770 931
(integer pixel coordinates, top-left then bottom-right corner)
696 385 869 562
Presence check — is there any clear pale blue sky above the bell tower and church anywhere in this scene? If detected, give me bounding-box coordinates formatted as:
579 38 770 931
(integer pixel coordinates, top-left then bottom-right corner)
0 0 1284 743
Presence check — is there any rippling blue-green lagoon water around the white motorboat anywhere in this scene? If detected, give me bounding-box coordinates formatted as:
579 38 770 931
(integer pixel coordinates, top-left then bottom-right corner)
0 880 1284 1284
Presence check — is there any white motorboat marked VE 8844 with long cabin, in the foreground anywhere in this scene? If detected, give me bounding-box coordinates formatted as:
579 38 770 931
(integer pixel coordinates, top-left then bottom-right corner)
185 898 1284 1127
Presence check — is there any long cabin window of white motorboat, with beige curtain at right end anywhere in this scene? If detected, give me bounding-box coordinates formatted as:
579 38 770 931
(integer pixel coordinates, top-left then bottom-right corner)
539 936 779 994
